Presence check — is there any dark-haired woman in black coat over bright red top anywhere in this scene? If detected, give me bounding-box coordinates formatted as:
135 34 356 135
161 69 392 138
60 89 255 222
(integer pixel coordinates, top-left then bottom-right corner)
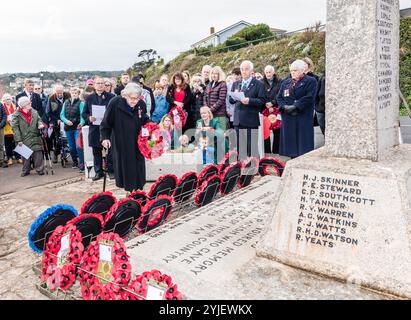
166 72 195 132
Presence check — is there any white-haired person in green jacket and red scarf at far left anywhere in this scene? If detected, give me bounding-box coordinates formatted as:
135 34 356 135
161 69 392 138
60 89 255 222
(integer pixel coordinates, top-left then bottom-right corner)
12 97 44 177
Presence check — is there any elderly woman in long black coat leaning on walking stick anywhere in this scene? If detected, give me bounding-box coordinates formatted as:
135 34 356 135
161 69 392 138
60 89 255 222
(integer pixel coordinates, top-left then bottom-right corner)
100 83 149 192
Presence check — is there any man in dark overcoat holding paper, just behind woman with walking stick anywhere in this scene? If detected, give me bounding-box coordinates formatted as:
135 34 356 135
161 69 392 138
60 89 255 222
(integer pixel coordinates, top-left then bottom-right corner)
82 77 115 181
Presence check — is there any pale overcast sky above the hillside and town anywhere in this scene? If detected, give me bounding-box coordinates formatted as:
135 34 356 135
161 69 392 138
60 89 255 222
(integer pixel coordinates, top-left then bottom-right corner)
0 0 411 74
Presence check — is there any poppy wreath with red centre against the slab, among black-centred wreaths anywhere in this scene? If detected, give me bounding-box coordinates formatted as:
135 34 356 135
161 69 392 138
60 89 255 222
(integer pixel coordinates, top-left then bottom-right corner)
137 196 173 234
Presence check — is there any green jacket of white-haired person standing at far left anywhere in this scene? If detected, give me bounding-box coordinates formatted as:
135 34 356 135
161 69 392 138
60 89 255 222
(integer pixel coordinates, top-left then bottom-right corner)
11 109 43 151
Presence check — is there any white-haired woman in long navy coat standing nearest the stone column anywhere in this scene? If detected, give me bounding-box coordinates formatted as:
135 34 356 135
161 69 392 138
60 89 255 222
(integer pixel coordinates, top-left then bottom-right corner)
277 60 317 158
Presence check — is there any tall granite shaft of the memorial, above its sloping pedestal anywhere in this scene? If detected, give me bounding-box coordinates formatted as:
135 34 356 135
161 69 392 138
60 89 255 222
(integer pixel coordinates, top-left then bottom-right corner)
326 0 400 161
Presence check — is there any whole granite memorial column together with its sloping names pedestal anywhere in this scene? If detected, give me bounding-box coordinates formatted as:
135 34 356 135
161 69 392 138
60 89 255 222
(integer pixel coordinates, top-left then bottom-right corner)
257 0 411 297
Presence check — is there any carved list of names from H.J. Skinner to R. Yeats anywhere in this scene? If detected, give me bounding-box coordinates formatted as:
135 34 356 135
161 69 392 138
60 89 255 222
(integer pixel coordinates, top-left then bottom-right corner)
296 174 376 248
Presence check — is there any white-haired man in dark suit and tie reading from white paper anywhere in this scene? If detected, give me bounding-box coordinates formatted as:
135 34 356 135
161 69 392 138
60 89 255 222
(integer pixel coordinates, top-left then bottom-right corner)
230 60 265 160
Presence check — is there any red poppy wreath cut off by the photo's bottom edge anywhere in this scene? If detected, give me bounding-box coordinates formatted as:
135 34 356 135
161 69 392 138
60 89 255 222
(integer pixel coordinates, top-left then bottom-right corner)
123 270 183 300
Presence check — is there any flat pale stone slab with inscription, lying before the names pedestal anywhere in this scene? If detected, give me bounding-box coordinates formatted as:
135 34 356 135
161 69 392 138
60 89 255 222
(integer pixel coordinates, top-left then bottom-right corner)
126 177 390 300
